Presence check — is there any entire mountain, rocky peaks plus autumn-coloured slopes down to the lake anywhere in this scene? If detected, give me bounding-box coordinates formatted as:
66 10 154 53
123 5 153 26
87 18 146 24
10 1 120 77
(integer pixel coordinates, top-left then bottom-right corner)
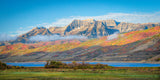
0 19 160 62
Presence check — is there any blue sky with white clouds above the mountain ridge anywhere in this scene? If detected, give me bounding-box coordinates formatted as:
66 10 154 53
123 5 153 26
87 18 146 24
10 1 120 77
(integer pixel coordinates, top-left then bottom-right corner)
0 0 160 38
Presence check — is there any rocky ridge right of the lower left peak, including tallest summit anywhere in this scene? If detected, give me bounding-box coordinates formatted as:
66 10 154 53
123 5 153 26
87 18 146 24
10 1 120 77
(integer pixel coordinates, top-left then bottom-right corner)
49 19 160 38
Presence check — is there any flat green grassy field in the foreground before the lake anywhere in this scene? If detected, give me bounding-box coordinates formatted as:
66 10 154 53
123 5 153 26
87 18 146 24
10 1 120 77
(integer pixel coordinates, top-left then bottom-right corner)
0 68 160 80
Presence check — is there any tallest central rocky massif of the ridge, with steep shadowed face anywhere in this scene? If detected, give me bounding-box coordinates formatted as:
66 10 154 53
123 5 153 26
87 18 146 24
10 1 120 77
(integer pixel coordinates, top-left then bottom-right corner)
64 19 118 38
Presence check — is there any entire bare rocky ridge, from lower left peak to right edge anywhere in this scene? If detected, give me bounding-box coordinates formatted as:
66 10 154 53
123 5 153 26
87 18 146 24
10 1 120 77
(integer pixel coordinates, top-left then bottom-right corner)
13 19 160 43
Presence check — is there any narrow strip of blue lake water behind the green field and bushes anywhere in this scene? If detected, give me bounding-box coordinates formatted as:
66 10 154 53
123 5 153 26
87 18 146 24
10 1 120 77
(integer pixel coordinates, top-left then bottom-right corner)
6 62 160 67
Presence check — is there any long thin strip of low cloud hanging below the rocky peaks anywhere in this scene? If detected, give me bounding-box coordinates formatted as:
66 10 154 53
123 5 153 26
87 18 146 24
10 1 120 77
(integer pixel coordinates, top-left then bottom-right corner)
29 35 87 41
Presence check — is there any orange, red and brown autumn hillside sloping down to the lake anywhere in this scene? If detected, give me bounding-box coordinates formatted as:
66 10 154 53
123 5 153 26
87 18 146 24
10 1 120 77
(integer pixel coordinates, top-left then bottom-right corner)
0 26 160 62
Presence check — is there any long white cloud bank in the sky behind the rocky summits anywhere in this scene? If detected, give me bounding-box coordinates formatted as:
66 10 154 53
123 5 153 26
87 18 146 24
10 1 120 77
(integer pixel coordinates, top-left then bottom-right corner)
46 12 160 27
